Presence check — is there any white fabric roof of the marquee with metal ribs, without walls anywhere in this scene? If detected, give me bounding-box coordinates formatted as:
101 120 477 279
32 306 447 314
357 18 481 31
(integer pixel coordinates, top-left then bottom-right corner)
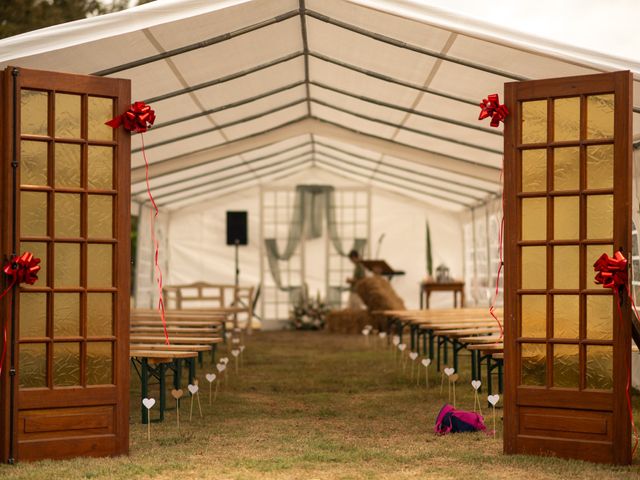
0 0 640 210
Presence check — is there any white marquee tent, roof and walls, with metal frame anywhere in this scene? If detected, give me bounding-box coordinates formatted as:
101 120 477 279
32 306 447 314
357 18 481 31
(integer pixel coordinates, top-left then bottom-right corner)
0 0 640 326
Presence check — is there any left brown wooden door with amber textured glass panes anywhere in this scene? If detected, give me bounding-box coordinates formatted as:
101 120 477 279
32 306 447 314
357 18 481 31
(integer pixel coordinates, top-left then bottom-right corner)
0 68 130 461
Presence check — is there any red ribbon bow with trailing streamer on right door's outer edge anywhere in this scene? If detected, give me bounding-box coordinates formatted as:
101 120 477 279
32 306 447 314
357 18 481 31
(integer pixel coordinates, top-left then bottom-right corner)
593 252 638 456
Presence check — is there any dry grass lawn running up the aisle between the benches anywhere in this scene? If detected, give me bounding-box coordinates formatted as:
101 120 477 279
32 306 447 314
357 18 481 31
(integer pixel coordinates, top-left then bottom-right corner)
0 332 640 480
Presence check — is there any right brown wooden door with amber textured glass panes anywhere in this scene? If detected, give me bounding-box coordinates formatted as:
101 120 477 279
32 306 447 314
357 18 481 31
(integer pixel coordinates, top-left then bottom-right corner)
504 72 632 464
